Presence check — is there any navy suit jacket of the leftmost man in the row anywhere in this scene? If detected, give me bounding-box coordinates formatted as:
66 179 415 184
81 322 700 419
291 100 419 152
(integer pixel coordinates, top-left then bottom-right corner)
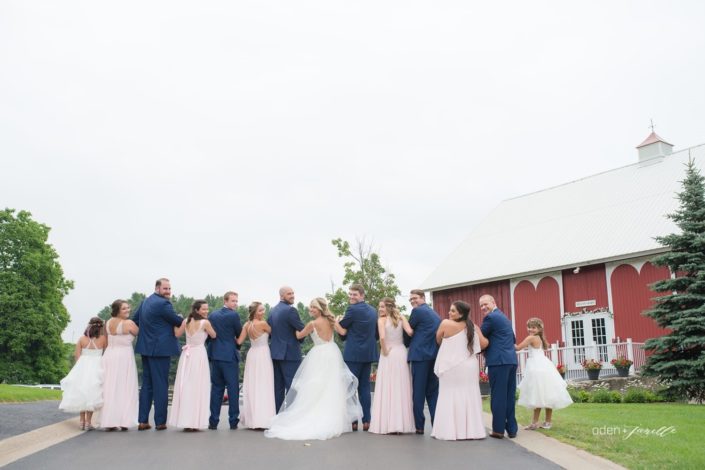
132 293 184 356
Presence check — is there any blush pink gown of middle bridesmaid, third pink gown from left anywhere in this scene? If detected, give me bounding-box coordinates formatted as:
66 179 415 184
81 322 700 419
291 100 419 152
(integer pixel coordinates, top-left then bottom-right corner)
240 332 276 429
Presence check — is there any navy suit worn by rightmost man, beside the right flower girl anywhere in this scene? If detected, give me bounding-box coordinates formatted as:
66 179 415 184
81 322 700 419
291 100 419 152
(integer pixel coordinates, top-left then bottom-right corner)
480 308 518 436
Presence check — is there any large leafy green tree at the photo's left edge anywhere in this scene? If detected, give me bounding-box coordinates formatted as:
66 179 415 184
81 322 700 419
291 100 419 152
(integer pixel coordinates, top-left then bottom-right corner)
0 209 73 383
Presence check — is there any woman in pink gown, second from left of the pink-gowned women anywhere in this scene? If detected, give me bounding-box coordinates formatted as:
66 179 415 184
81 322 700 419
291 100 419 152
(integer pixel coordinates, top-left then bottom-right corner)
169 300 215 431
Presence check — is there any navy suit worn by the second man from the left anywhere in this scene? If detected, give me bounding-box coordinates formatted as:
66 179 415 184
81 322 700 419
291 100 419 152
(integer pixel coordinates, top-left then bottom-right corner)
207 306 242 429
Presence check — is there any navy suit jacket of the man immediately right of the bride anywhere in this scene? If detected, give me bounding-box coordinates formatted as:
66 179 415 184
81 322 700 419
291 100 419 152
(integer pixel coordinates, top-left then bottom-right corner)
340 302 379 362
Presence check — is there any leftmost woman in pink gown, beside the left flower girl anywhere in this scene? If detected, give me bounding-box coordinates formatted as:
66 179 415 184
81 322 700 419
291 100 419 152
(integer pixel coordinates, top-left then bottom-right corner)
100 299 139 431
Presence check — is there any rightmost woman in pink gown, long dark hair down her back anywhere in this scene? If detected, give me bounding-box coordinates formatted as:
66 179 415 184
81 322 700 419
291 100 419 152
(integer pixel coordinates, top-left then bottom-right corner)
431 300 488 441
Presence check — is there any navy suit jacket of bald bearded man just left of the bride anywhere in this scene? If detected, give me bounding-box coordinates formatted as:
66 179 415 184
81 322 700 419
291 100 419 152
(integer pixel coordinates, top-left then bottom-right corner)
267 301 304 361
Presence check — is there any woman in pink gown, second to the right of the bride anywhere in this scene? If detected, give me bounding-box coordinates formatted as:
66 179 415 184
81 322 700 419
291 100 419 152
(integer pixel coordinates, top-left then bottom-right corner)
369 297 415 434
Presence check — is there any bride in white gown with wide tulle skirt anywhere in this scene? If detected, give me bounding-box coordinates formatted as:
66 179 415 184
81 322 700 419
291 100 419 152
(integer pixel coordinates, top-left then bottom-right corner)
264 297 362 440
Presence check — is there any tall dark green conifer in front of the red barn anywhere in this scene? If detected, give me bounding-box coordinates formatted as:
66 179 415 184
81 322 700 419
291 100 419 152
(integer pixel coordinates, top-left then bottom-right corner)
642 159 705 403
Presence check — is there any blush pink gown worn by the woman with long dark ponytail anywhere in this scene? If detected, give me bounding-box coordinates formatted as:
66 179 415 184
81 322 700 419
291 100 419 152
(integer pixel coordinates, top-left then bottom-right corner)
431 329 487 441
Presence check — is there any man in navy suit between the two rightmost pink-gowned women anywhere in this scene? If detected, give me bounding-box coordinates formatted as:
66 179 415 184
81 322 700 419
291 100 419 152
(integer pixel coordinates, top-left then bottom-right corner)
404 289 441 434
